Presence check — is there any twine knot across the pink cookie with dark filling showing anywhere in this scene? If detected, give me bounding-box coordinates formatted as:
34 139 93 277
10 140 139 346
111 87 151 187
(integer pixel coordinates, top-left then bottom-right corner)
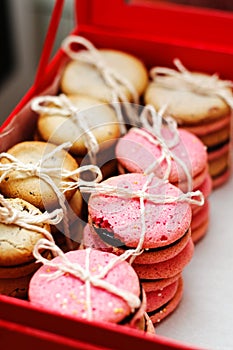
79 173 205 264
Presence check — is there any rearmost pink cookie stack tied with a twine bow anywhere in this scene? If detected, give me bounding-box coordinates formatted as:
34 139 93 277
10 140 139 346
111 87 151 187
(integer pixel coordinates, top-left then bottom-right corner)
116 105 212 242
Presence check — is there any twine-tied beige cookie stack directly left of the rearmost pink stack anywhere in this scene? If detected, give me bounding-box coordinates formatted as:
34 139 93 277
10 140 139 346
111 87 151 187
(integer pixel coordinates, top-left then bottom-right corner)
31 94 121 177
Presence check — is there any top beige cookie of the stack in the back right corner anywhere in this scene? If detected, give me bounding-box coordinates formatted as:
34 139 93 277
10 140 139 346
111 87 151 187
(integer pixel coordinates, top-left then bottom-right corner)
144 74 230 125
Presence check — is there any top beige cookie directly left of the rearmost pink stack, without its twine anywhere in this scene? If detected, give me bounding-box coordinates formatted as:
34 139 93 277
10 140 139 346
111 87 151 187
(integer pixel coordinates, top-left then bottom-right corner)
37 95 120 157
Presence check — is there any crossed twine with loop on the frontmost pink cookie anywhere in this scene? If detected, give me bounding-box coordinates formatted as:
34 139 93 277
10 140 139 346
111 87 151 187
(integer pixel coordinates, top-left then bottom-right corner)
34 239 141 320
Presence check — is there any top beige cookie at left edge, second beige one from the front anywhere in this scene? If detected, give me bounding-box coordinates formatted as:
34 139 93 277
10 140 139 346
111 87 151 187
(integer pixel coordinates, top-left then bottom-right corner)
0 141 78 210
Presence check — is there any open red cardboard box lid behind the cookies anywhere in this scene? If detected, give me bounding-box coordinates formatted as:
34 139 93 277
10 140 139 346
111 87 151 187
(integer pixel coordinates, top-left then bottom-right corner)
75 0 233 53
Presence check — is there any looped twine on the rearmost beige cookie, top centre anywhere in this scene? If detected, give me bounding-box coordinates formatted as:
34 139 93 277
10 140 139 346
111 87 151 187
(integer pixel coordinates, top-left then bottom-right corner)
62 35 139 134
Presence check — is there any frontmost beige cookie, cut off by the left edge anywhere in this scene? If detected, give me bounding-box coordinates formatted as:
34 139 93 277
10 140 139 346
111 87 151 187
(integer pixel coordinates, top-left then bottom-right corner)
0 198 50 267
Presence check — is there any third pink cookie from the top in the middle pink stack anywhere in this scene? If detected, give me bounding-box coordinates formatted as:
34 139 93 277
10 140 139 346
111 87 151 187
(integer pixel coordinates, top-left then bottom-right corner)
133 238 194 280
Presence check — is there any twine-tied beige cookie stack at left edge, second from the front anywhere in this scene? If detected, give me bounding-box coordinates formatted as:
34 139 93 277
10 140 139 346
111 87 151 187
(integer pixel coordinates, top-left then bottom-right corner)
0 141 95 249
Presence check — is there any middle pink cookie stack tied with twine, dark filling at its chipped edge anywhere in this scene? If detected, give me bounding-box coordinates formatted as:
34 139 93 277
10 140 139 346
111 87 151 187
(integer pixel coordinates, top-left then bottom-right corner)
80 173 203 324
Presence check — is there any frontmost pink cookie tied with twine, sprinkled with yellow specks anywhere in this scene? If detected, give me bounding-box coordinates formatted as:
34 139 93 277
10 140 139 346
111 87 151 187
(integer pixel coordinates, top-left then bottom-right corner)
29 239 141 322
